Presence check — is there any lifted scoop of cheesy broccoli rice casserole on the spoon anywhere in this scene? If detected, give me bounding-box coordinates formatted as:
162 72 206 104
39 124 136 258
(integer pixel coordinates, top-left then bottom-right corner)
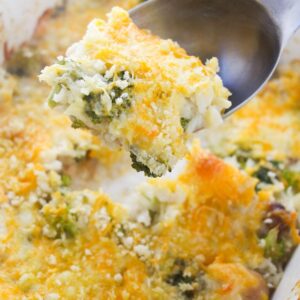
40 7 230 177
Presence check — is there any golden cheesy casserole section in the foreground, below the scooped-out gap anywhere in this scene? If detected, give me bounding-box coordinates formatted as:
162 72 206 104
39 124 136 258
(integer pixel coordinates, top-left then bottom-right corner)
0 133 267 299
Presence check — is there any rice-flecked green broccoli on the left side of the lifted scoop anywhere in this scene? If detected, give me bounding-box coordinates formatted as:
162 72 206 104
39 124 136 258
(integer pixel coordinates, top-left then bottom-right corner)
44 58 133 128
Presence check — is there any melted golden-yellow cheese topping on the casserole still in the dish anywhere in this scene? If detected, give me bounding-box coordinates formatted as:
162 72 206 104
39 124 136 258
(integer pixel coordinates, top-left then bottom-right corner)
0 1 299 300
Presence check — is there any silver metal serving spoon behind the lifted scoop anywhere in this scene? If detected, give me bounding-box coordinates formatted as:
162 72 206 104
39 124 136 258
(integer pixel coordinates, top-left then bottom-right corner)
130 0 300 116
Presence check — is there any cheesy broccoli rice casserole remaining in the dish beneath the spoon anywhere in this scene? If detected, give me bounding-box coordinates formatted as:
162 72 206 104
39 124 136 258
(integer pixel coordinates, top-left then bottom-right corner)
0 0 300 300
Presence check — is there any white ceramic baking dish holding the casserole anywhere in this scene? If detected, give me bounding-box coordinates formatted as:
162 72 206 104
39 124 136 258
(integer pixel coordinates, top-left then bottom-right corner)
0 0 300 300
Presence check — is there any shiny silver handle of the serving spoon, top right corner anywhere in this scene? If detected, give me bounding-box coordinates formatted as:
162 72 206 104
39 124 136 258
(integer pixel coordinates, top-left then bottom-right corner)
261 0 300 43
